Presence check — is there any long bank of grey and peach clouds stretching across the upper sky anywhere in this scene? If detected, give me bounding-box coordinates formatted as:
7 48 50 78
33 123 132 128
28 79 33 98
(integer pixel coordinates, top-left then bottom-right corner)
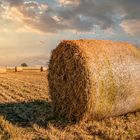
0 0 140 34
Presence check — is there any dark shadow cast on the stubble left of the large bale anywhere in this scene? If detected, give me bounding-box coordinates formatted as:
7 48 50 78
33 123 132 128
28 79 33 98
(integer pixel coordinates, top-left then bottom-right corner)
0 100 55 127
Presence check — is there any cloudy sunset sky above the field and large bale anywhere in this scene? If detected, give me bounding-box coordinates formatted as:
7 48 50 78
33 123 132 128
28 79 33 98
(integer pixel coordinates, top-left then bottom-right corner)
0 0 140 65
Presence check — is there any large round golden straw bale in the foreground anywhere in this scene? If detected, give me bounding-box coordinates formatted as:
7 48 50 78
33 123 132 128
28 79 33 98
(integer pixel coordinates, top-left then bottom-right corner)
48 40 140 121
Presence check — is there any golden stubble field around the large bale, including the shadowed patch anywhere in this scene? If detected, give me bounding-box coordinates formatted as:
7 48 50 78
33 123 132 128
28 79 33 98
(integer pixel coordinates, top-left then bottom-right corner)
0 72 140 140
